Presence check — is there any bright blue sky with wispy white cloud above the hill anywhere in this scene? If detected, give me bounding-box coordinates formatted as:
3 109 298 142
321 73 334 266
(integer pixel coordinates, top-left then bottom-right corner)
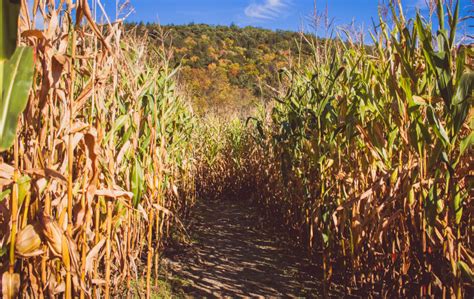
102 0 473 30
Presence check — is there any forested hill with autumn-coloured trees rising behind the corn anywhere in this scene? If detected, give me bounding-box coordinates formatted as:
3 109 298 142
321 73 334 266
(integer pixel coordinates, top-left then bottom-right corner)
129 24 311 114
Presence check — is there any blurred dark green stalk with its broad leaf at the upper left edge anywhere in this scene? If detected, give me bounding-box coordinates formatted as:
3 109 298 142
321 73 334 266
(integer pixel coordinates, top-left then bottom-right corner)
0 1 33 151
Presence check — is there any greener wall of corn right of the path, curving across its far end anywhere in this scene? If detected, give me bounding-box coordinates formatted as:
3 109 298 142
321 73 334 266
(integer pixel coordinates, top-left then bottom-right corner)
198 1 474 298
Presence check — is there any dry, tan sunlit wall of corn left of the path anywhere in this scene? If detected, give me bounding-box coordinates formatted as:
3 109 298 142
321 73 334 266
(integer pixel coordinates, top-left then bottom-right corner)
0 0 194 298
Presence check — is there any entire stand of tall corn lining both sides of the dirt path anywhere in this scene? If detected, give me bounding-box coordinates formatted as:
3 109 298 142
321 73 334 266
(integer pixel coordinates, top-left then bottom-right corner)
0 0 474 298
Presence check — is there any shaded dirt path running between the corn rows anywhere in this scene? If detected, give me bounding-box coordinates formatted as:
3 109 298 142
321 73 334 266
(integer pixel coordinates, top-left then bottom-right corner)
165 201 322 298
